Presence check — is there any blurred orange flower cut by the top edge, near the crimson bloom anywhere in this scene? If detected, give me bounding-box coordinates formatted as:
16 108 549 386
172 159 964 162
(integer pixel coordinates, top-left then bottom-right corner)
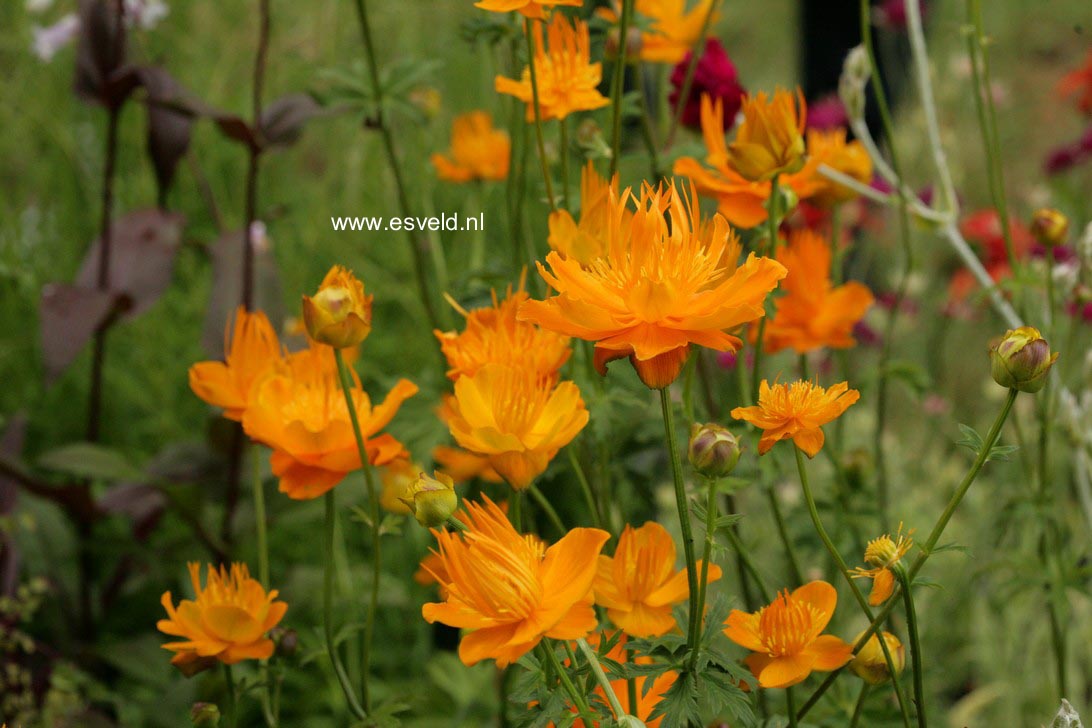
598 0 720 63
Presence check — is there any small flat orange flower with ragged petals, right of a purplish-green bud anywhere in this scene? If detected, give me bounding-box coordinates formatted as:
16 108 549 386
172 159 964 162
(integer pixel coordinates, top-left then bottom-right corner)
732 379 860 457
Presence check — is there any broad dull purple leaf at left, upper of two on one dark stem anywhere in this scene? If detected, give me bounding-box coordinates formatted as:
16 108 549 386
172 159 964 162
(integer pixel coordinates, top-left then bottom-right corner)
76 210 186 317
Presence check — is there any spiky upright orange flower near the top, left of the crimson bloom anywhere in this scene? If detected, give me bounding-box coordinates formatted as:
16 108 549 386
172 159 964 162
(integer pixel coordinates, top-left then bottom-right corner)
495 13 610 121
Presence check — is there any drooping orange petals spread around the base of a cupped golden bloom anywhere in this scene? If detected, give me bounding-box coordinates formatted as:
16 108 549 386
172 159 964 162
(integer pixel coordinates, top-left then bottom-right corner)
674 94 821 228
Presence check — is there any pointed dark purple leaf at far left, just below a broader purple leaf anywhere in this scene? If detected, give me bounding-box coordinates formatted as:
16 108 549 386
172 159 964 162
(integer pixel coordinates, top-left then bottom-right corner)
38 283 114 382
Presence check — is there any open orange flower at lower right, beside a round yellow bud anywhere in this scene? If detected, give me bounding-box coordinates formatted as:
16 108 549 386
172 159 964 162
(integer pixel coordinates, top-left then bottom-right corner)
724 582 853 688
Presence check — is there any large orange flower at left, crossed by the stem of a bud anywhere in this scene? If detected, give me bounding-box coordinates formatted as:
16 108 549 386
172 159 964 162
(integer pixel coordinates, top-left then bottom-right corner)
242 345 417 500
